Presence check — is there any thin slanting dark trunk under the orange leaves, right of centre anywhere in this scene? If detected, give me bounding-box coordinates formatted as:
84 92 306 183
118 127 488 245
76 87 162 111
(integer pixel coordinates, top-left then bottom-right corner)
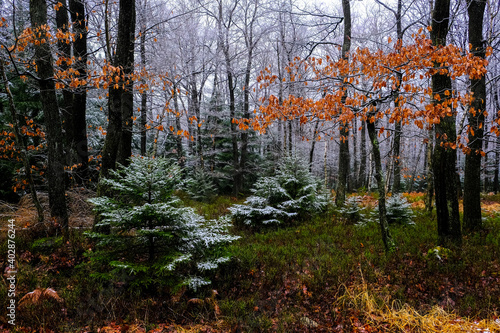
366 109 396 253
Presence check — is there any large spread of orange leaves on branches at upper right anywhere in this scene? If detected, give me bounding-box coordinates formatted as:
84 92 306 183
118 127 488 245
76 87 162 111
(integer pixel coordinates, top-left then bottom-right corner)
251 31 490 152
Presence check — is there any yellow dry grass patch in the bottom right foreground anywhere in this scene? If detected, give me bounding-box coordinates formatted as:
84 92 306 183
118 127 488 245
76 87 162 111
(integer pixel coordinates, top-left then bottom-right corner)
337 284 500 333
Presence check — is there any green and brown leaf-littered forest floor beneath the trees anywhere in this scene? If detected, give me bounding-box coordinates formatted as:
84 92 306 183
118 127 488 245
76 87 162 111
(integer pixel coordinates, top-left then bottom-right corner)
0 191 500 332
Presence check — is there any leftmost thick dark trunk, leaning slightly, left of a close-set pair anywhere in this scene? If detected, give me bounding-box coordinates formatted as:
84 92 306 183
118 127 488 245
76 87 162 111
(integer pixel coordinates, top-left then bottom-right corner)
30 0 68 239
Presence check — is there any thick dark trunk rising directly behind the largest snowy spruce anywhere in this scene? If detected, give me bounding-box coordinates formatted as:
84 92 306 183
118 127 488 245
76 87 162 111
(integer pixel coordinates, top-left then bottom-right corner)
98 0 135 184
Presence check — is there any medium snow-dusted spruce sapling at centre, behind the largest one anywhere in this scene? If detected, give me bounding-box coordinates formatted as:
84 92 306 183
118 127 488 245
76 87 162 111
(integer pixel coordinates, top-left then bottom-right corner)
229 158 330 228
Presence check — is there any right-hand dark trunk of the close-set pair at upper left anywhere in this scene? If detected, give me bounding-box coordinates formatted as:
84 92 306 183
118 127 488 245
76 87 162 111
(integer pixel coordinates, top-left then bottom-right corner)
69 0 89 182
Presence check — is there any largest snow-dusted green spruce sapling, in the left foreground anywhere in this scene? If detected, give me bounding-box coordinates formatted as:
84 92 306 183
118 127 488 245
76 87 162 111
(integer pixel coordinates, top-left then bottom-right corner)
88 157 238 289
